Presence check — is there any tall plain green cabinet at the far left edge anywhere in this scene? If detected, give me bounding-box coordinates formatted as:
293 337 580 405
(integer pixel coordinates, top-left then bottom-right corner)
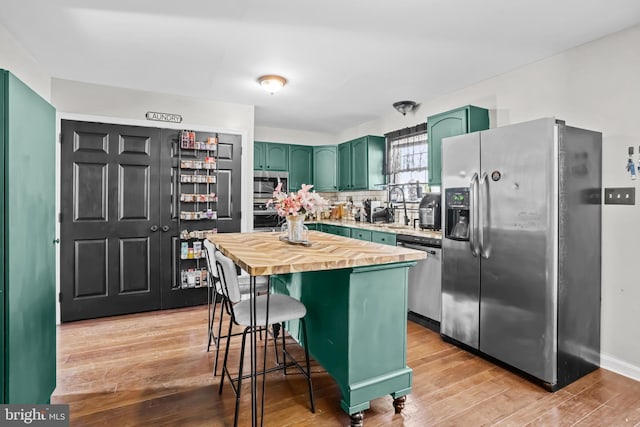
0 69 55 404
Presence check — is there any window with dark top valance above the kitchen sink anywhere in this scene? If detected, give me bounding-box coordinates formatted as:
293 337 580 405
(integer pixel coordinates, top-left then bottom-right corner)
385 123 429 188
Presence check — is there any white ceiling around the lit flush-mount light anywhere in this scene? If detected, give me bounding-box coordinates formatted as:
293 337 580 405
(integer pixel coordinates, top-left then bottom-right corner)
0 0 640 133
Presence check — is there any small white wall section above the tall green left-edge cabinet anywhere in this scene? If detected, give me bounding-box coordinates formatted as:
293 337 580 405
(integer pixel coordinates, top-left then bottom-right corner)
0 25 51 102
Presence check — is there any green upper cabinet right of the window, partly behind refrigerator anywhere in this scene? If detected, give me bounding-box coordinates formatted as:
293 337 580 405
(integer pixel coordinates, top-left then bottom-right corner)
427 105 489 185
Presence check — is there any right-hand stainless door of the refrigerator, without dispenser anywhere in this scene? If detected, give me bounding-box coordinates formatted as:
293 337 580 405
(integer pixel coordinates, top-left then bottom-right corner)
480 119 557 383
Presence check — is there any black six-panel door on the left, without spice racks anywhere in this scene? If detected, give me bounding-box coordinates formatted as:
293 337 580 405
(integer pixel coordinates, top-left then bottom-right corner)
60 120 165 322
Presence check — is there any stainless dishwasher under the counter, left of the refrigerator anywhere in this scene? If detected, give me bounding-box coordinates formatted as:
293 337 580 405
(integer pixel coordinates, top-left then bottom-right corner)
396 234 442 332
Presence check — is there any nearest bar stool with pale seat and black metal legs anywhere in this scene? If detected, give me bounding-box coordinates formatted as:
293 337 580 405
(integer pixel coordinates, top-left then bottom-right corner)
214 250 316 426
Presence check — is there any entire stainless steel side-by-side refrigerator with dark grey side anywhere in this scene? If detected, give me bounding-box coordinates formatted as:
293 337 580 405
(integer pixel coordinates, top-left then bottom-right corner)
440 118 602 390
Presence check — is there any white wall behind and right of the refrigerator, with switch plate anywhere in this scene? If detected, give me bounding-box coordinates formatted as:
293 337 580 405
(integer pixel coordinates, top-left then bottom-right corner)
338 25 640 380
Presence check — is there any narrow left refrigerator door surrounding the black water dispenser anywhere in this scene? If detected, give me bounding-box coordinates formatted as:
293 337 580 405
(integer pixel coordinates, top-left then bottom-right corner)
440 133 480 348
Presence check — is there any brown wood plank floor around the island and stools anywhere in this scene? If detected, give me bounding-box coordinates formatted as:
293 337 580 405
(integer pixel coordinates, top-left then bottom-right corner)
52 307 640 427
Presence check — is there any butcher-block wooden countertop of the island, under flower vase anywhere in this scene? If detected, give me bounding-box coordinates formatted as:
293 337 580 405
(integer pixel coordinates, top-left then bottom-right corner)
207 231 427 276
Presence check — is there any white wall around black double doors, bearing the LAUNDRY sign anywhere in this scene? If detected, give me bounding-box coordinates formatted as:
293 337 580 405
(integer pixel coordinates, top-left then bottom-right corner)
51 78 254 231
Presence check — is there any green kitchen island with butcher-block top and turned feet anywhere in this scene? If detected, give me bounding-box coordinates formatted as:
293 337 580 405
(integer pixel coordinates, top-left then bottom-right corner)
208 231 426 426
